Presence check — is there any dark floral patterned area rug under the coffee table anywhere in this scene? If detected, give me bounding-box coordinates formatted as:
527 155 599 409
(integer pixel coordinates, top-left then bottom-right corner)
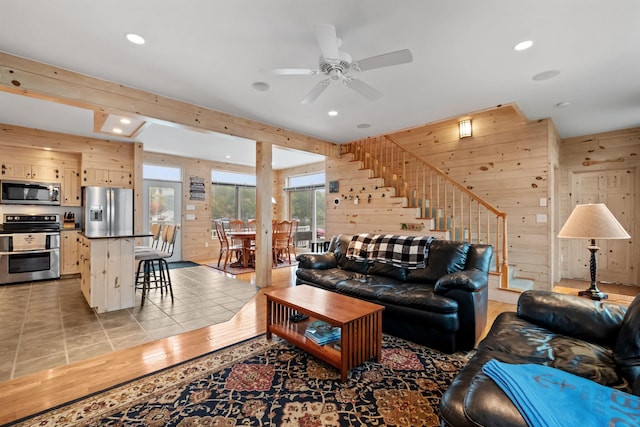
11 335 473 427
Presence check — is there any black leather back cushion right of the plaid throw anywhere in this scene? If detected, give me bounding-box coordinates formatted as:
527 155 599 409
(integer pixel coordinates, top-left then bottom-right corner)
407 240 469 284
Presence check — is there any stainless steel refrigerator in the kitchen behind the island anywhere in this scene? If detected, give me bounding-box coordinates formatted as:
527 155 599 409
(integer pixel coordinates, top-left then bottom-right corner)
82 187 133 237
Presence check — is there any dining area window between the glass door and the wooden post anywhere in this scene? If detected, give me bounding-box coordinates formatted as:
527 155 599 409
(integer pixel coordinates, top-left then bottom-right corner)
211 171 256 221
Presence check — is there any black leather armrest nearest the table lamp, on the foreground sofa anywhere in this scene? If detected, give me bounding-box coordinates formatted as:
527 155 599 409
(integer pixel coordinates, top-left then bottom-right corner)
518 290 626 347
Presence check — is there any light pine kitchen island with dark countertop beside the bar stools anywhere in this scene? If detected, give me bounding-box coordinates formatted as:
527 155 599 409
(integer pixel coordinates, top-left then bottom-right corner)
79 232 150 313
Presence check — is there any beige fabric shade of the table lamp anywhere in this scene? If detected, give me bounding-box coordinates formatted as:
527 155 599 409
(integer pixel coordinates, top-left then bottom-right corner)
558 203 631 239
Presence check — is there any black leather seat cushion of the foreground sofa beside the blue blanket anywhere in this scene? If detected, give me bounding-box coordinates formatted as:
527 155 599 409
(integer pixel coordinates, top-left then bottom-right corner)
478 312 631 392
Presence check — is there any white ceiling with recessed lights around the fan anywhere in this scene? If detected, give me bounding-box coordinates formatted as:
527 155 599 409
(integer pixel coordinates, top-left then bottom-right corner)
0 0 640 164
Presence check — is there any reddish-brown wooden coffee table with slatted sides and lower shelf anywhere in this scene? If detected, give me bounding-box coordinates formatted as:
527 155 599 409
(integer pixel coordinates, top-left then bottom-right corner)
265 285 384 381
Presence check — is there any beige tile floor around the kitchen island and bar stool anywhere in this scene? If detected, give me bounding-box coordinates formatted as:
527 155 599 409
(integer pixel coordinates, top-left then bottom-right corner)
0 266 257 381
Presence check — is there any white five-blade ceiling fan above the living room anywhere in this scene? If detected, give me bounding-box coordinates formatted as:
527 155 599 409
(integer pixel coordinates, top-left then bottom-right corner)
266 24 413 104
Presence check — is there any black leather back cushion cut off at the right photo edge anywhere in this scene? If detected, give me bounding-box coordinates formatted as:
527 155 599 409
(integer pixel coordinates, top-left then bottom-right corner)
613 296 640 396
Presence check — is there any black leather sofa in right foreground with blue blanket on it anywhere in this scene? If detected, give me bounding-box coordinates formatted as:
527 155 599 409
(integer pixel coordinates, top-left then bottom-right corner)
440 291 640 427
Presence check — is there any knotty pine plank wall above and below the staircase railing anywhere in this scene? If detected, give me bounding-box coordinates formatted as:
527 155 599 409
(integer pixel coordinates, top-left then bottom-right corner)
327 105 558 289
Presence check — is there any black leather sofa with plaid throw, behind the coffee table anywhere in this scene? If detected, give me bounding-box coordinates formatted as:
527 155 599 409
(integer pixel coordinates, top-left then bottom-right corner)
296 235 493 353
